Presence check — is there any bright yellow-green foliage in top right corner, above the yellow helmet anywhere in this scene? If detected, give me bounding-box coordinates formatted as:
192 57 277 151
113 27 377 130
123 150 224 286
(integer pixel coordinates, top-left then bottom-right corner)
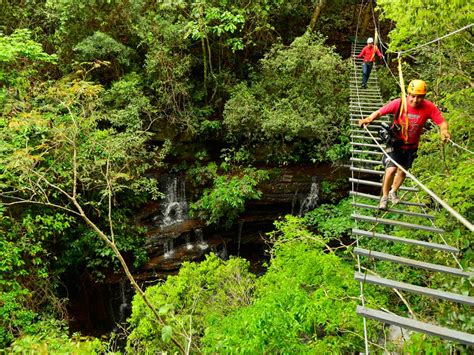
377 0 474 104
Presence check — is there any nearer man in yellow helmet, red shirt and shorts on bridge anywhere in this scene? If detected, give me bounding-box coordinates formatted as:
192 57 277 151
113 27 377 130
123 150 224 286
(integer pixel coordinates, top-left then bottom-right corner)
359 80 451 210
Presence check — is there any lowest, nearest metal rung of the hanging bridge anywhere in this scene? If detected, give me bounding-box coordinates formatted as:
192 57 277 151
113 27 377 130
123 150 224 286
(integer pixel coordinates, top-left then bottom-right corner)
356 306 474 345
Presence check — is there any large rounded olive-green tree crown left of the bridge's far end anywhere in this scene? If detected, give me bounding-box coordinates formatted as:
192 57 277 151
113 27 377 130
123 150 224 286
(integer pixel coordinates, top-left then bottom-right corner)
224 33 347 161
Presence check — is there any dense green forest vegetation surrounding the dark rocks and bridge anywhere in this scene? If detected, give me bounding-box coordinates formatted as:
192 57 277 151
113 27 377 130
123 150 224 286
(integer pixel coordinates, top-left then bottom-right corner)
0 0 474 353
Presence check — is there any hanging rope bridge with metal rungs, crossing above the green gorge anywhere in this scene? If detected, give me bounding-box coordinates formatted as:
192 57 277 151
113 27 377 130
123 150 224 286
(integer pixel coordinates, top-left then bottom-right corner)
349 42 474 352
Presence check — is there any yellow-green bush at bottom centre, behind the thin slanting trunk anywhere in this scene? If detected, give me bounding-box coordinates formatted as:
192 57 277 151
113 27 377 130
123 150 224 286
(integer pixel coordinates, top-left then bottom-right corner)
127 254 255 353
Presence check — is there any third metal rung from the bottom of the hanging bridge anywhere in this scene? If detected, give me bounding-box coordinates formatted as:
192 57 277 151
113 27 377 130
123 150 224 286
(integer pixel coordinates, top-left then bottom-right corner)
354 248 474 277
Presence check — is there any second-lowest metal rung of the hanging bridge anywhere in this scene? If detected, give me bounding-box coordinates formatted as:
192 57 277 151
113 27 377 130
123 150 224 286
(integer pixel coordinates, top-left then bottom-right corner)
354 272 474 306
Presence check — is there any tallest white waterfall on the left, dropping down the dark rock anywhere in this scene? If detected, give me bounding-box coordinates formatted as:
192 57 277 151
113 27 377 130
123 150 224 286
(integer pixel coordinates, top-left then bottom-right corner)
161 176 188 227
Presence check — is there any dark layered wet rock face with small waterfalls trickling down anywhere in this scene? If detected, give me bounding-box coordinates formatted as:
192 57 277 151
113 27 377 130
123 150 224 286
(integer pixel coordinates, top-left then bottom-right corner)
133 165 347 279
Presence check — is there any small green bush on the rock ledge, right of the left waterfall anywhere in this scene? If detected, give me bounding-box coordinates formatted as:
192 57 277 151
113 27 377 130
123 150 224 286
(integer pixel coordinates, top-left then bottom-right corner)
190 168 269 227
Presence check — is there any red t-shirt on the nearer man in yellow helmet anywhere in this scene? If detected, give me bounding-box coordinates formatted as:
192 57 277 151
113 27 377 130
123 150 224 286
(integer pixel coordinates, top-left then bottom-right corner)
379 99 445 148
